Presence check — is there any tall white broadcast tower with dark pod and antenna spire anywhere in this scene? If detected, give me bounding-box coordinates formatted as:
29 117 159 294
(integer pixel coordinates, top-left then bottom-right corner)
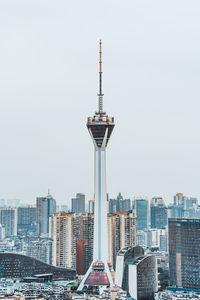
78 41 114 290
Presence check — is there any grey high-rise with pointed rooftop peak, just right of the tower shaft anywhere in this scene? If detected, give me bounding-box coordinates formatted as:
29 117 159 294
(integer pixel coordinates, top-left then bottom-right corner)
109 193 131 214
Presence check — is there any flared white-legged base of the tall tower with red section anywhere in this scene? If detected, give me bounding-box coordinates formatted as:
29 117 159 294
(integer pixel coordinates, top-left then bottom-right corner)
78 261 113 293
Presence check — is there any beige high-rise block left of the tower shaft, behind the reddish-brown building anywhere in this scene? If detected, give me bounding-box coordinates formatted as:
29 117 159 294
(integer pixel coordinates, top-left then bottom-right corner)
49 212 94 272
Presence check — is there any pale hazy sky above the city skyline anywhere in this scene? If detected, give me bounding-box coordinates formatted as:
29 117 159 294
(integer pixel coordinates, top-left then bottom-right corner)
0 0 200 204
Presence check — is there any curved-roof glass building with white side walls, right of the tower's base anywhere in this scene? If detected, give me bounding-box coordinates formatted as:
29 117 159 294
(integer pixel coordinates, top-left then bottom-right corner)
115 246 157 300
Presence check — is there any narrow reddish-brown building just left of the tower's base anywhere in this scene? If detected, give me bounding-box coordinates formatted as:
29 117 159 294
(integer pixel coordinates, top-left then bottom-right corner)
76 240 89 275
